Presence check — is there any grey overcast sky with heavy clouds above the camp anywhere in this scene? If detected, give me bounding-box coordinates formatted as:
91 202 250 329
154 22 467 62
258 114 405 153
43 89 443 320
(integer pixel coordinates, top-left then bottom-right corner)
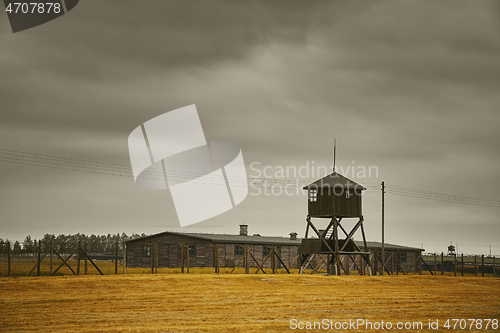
0 0 500 255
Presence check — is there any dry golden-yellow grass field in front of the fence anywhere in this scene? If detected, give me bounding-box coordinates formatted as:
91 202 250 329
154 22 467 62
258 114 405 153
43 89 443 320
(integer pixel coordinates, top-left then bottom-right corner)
0 274 500 332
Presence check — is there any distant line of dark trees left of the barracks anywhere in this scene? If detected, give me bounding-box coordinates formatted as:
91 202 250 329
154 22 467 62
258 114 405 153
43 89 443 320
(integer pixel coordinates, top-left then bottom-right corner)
0 232 146 255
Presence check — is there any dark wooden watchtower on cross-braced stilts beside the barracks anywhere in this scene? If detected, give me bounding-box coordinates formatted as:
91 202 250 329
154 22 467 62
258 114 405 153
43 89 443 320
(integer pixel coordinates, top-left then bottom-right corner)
300 171 372 275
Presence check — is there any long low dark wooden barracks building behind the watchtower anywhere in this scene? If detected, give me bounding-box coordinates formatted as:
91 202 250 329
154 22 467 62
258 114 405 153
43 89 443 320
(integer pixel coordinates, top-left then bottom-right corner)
125 225 423 272
